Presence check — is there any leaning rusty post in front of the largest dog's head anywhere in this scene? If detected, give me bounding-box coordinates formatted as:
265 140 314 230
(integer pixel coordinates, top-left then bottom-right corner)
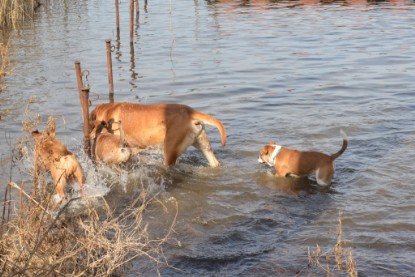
75 61 91 158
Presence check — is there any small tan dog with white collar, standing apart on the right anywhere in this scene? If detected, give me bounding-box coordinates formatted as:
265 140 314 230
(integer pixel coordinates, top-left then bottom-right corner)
258 130 349 186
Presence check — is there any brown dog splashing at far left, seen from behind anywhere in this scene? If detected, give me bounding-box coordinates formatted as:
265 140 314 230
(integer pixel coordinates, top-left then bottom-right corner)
32 130 84 198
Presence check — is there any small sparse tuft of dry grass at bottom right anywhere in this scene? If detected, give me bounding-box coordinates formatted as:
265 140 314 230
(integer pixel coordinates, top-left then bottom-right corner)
297 210 358 277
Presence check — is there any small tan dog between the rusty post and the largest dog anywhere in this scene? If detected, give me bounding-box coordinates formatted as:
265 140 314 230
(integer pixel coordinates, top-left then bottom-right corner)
90 119 131 164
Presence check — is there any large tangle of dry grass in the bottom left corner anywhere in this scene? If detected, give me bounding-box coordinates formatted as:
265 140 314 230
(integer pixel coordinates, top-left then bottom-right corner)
0 113 178 276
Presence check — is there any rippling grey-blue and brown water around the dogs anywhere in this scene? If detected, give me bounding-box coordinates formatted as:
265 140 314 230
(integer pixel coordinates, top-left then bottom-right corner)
0 0 415 276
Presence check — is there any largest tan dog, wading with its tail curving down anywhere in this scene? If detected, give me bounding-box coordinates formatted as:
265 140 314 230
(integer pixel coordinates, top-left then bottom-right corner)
90 102 226 167
